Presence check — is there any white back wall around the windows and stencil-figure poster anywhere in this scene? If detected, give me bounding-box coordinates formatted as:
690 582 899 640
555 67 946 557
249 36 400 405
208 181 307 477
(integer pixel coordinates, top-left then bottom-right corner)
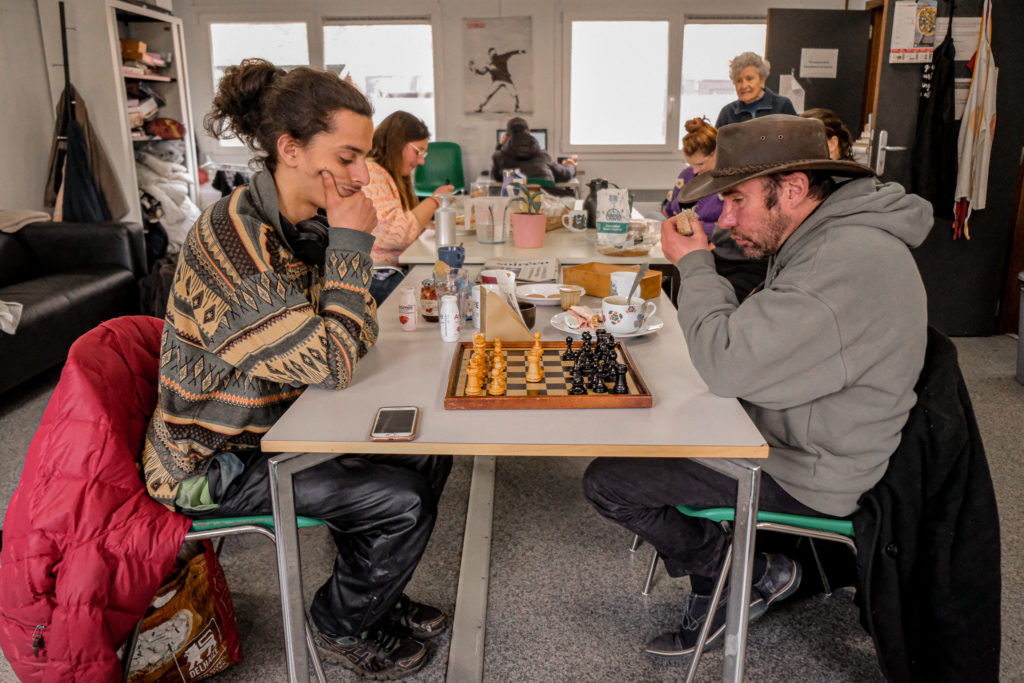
174 0 864 189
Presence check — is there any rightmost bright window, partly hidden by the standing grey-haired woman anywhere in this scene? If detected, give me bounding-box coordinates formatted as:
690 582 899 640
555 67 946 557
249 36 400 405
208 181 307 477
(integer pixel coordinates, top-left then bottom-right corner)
679 24 767 145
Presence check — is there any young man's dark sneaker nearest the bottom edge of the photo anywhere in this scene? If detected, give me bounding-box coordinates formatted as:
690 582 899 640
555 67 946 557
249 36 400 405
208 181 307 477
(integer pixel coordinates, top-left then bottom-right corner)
313 629 427 681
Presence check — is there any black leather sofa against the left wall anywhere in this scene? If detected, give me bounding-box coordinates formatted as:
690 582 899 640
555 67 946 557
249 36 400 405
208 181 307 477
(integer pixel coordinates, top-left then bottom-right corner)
0 222 146 393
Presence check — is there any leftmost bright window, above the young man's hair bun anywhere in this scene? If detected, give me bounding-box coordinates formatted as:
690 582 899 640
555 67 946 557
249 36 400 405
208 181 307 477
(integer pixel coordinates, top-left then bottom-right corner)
210 23 309 147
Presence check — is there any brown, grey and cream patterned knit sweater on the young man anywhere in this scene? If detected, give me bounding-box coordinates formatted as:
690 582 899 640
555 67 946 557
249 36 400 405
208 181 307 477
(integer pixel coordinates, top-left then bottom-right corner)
141 171 378 509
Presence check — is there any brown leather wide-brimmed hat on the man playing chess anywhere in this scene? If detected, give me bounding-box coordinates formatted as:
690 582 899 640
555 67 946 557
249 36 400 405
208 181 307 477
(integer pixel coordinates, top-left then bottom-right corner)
679 114 874 204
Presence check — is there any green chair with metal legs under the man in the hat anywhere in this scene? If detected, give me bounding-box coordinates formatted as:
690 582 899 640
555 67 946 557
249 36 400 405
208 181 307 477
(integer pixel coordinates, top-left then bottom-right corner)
630 505 857 683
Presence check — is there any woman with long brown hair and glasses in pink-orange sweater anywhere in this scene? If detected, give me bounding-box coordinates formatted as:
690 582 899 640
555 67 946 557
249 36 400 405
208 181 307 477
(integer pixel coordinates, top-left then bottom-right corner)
362 112 455 305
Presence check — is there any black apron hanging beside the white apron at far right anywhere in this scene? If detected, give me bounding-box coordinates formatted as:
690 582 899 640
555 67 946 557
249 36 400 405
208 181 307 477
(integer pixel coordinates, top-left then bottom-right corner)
910 0 959 219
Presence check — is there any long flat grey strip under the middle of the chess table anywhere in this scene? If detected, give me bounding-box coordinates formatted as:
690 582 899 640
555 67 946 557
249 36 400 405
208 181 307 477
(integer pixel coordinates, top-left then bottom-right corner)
446 456 495 683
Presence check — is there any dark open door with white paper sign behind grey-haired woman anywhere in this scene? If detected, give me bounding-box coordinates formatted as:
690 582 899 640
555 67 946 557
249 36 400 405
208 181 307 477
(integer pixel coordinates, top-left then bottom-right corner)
765 8 871 139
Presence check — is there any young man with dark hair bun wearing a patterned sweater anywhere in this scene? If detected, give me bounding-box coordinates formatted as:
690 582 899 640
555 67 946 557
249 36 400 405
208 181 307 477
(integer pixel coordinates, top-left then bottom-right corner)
141 59 452 678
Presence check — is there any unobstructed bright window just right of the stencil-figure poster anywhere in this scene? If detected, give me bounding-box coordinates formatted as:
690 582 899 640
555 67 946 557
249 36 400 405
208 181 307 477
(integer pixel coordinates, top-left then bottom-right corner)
568 20 670 145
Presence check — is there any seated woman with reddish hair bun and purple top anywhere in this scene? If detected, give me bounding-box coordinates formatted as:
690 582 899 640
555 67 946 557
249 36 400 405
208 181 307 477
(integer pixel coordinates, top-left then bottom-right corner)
662 118 768 301
